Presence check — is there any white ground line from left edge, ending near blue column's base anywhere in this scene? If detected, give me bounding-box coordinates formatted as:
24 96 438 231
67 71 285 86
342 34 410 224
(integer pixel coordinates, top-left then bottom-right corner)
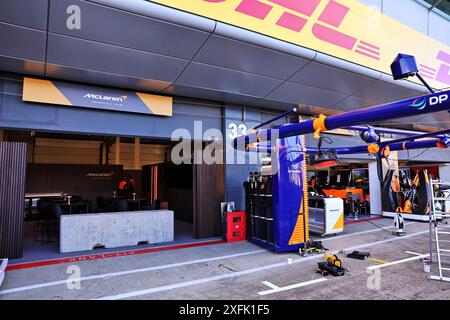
0 250 267 295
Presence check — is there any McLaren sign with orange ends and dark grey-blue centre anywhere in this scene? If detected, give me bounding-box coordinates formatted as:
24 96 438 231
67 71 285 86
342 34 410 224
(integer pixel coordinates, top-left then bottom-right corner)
22 77 173 116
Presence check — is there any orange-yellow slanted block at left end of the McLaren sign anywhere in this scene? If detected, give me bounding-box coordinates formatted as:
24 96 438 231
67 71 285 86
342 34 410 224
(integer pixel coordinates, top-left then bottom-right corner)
22 77 72 106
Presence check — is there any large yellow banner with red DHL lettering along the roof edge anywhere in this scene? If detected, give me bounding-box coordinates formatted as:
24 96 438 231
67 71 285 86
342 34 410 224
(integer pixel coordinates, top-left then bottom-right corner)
151 0 450 89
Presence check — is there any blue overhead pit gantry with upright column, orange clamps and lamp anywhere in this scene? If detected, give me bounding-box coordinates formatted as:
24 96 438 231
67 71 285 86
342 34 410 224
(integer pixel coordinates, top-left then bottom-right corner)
233 54 450 252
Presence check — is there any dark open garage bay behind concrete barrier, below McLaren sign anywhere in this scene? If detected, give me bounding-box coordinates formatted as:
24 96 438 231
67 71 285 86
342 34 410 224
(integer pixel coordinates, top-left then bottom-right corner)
1 131 224 261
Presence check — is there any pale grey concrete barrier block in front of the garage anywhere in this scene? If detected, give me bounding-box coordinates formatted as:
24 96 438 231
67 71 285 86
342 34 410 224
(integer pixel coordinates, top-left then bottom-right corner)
59 210 174 253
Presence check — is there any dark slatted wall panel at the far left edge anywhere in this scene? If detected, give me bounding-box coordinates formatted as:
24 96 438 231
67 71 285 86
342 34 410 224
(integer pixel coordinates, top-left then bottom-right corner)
0 142 27 259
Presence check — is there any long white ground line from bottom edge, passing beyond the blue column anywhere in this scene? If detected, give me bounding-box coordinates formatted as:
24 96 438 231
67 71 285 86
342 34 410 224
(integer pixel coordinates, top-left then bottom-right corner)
97 230 429 300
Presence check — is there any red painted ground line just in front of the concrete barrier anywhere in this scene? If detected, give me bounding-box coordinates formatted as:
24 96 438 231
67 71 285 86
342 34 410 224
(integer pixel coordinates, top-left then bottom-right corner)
6 240 225 271
